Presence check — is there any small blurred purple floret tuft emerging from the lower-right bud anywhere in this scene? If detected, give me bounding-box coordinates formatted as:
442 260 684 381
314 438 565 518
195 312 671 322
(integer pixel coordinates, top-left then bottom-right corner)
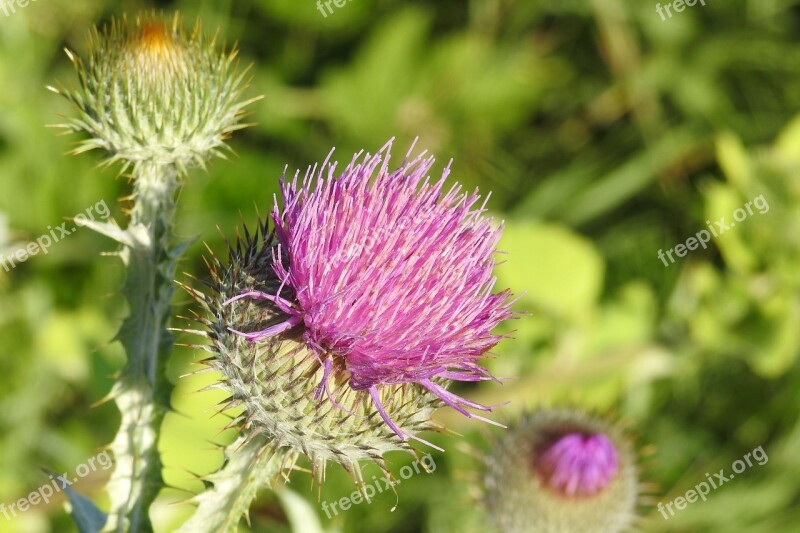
535 432 619 497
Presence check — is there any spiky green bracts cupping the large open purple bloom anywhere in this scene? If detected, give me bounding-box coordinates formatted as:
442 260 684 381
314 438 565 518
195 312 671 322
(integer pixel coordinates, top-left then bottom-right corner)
185 219 441 484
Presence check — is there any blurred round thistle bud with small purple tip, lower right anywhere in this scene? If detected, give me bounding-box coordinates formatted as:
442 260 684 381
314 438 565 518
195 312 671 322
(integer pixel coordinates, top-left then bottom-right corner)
484 410 639 533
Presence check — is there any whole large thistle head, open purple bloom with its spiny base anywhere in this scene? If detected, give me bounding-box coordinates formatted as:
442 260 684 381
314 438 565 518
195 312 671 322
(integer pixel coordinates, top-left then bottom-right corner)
185 142 511 481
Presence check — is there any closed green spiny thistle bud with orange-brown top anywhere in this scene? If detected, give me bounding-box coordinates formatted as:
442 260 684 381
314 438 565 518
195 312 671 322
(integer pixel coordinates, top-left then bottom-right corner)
51 15 253 173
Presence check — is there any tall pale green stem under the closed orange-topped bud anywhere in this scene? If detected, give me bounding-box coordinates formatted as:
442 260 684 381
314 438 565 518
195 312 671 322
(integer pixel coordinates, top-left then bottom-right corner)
106 163 182 532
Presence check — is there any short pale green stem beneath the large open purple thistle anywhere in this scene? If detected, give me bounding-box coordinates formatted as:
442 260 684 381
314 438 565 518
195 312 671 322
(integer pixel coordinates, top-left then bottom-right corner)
175 435 284 533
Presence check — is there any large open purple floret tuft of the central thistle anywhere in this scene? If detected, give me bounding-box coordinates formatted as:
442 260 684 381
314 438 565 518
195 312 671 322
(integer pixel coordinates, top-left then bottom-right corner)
229 141 512 442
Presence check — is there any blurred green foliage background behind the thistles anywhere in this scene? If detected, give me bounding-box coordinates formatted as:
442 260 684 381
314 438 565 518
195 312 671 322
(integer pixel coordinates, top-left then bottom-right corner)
0 0 800 533
